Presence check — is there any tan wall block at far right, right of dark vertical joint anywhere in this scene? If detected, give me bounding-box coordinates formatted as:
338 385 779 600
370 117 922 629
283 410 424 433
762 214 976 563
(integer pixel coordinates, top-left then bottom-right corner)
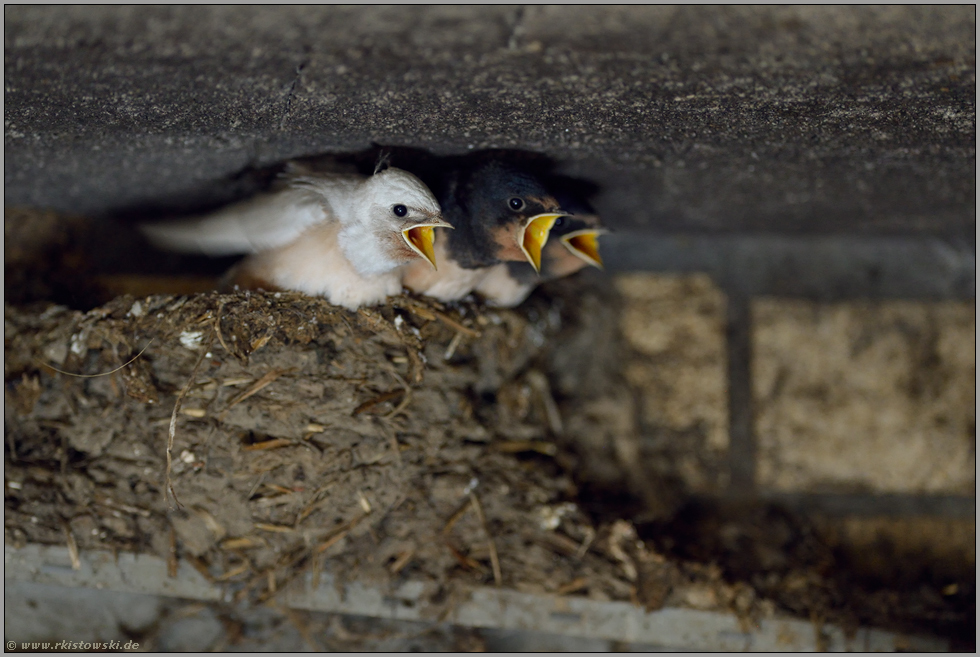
752 299 976 495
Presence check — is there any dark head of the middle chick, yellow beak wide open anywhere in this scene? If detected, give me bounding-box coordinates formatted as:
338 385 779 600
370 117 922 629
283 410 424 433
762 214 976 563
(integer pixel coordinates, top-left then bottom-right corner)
453 160 565 269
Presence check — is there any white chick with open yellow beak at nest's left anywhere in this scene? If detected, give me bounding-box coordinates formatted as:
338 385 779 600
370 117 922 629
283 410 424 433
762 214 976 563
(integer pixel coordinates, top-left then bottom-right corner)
142 166 452 310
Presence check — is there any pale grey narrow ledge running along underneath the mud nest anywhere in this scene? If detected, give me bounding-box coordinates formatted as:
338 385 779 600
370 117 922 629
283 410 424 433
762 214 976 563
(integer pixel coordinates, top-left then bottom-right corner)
4 544 949 652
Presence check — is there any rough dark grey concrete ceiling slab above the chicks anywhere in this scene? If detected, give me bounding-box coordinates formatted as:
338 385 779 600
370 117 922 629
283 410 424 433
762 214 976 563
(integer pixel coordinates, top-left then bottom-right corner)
4 6 976 236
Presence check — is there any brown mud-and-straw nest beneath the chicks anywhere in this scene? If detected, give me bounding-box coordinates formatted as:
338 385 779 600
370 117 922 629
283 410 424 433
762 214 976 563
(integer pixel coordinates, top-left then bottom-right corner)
5 293 754 613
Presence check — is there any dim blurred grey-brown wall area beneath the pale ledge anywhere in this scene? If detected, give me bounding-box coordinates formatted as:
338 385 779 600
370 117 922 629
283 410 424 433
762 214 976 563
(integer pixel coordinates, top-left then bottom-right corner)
4 581 494 652
